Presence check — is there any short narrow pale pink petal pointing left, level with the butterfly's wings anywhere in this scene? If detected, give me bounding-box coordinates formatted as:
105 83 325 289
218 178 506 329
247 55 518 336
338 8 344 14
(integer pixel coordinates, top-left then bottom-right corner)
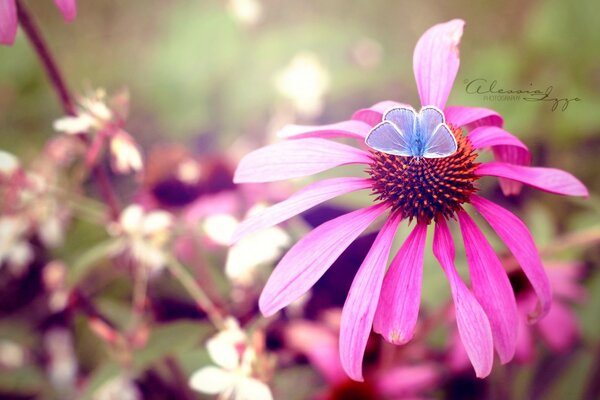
277 120 371 140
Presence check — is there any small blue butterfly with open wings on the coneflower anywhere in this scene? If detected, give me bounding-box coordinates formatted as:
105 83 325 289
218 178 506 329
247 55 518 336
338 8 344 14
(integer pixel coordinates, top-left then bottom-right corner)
365 106 458 158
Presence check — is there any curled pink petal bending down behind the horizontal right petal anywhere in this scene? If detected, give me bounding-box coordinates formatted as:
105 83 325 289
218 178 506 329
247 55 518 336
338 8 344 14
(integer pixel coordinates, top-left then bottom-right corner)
469 126 531 196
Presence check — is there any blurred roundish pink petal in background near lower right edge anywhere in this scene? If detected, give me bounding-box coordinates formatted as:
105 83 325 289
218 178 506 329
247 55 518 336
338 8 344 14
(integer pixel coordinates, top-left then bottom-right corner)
538 302 580 352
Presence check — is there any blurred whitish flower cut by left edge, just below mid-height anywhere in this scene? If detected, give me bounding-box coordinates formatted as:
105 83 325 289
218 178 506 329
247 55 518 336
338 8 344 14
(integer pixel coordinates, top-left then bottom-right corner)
0 216 33 271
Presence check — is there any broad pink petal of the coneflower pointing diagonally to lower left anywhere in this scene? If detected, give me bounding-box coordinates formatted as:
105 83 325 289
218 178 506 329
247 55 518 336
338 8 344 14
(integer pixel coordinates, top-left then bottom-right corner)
258 204 386 316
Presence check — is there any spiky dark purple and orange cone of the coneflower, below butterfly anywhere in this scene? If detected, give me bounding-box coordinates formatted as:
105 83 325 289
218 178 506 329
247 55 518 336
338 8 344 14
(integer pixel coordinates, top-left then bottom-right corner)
367 127 479 224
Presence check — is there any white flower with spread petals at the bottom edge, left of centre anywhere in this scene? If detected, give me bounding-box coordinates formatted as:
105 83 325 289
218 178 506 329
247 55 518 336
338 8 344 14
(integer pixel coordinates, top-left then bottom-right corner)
189 319 273 400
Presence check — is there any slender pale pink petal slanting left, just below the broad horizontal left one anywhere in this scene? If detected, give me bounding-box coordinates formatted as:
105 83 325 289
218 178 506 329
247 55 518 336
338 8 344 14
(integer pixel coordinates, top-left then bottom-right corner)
231 178 372 243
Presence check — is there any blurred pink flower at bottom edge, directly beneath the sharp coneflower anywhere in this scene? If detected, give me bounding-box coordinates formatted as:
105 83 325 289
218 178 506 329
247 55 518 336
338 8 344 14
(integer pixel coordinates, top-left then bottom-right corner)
285 313 442 400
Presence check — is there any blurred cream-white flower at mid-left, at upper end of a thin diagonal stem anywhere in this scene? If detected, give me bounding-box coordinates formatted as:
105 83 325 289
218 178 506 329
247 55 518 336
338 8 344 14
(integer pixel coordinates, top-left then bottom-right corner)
113 204 173 272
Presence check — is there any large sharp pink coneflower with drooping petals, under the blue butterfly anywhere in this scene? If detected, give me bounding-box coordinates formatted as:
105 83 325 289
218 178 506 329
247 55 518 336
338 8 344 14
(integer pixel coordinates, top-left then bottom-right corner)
234 20 588 380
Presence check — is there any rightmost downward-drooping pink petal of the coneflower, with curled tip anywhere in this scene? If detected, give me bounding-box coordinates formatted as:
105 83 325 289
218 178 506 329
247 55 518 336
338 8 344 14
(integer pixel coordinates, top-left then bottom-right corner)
471 195 552 319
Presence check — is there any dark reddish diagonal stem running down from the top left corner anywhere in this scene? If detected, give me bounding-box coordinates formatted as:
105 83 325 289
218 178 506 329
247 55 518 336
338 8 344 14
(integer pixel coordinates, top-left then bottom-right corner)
16 0 120 219
